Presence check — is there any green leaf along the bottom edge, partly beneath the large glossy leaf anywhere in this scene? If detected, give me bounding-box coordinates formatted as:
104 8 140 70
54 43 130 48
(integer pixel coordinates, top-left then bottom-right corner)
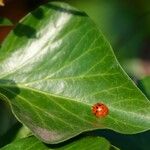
1 136 117 150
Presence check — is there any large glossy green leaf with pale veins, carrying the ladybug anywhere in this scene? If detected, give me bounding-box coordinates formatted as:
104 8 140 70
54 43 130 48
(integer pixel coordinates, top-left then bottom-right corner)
0 3 150 143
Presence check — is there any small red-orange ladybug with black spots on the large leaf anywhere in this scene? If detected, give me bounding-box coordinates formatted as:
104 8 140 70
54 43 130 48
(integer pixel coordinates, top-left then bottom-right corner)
92 103 109 118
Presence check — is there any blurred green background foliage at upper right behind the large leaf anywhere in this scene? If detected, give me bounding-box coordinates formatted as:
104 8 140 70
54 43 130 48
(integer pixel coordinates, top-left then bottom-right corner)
62 0 150 61
